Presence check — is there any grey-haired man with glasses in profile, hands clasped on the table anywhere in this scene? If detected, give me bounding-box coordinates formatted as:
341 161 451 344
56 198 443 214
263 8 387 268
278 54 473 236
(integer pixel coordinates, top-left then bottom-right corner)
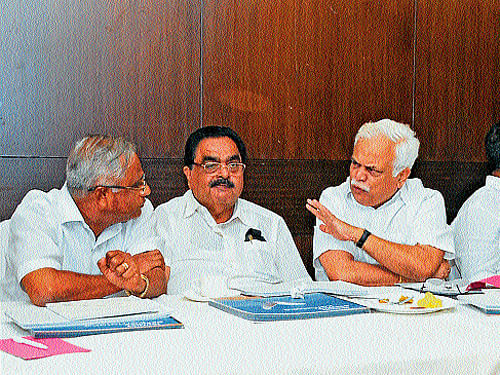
6 136 168 306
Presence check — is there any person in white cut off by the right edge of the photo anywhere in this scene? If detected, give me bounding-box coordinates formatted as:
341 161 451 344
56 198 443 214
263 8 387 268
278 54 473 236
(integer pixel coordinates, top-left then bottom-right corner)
452 122 500 281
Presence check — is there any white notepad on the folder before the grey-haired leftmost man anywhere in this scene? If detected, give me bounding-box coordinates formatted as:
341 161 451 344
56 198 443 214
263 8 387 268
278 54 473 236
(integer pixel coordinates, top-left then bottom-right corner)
47 296 160 320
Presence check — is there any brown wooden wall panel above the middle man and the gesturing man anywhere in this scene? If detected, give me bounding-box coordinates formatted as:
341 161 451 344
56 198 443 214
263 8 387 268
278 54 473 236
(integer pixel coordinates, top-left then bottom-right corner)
203 0 414 159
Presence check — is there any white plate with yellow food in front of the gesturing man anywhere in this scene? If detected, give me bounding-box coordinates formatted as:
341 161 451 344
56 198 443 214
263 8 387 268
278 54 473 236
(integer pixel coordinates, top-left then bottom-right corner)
350 290 458 314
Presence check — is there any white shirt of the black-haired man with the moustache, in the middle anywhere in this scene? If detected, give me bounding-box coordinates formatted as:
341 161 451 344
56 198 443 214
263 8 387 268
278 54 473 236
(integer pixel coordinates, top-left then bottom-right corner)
154 190 310 294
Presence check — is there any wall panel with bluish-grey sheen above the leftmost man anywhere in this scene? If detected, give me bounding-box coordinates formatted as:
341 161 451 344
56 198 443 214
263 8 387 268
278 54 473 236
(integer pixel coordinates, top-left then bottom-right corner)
0 0 201 157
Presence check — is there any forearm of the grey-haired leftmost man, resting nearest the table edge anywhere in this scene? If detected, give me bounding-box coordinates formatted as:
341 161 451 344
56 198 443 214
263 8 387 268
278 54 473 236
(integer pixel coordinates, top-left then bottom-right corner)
21 268 120 306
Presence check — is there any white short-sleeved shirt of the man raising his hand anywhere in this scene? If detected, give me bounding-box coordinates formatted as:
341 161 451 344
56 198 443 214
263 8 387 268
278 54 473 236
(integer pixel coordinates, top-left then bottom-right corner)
313 178 454 280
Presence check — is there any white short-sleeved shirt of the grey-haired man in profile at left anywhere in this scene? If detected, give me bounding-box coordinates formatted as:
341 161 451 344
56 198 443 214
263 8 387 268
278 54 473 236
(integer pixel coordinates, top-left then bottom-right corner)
6 185 157 300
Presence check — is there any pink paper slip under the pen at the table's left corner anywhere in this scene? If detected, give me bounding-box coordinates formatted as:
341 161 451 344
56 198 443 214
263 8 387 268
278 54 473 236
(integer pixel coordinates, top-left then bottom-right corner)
0 336 90 359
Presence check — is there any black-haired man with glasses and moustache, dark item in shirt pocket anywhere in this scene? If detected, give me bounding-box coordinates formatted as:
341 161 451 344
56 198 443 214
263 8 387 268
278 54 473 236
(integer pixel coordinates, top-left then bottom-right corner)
154 126 310 294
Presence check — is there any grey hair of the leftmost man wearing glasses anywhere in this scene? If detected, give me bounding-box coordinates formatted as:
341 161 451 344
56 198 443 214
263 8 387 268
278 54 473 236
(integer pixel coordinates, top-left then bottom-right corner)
66 135 136 200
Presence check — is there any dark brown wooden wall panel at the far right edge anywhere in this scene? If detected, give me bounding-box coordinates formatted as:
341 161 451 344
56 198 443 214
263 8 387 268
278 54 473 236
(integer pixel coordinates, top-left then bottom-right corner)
415 0 500 161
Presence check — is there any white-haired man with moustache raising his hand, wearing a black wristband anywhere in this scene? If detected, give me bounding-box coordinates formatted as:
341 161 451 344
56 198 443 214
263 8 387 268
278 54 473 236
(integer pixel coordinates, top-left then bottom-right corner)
306 119 454 286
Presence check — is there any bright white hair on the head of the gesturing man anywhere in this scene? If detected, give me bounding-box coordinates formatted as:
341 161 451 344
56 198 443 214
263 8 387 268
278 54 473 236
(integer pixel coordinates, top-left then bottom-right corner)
354 119 420 176
